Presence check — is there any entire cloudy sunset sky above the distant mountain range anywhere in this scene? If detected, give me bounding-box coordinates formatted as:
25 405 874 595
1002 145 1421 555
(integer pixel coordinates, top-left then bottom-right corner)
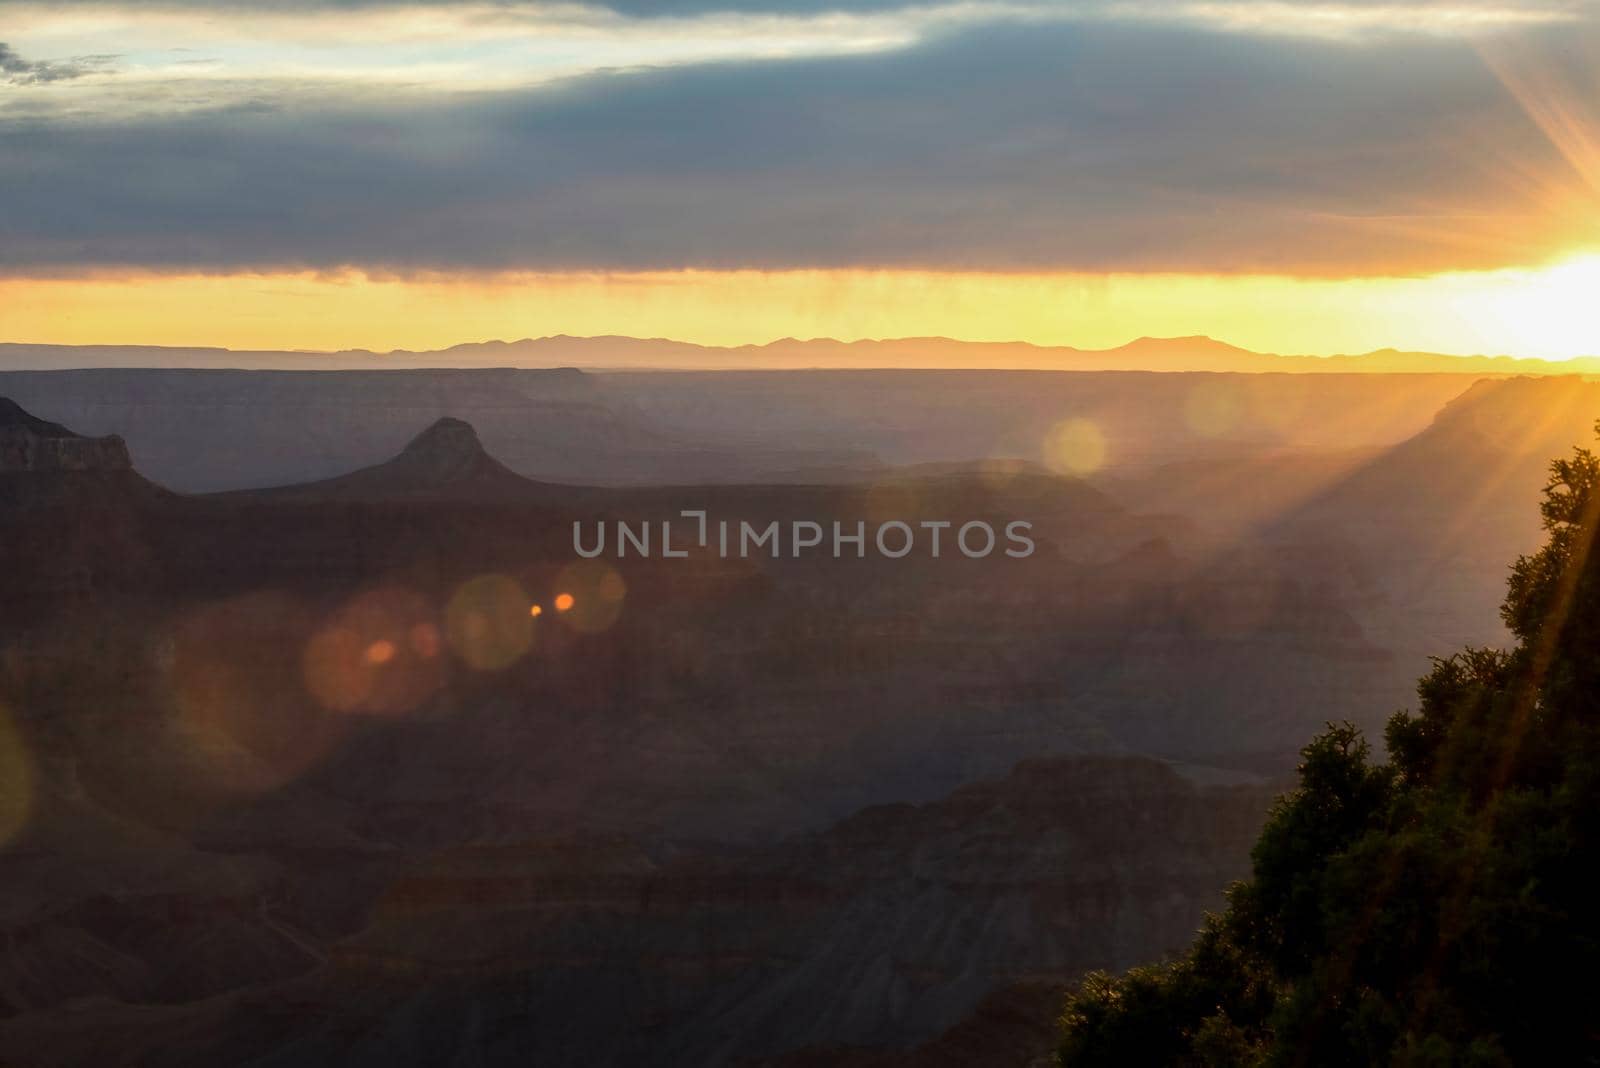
0 0 1600 358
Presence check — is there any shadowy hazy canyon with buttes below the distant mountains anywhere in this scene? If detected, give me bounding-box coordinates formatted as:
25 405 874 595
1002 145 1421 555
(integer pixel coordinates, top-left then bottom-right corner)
0 364 1597 1066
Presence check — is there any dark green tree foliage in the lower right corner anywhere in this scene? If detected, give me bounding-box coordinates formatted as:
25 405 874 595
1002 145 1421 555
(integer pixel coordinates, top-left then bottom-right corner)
1059 427 1600 1068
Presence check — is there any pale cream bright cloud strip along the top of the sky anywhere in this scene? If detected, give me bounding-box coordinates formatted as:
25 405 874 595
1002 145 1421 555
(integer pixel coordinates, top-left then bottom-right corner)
0 0 1592 118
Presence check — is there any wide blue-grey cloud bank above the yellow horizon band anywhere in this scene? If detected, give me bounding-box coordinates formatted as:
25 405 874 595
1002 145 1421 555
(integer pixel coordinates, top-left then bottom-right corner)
0 24 1600 273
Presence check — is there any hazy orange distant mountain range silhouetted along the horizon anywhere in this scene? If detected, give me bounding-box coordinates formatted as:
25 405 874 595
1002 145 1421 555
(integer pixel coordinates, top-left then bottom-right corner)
9 334 1600 374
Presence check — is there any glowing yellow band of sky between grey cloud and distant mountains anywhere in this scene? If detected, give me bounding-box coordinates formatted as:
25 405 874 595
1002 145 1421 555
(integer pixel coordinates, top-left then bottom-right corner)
0 254 1600 358
